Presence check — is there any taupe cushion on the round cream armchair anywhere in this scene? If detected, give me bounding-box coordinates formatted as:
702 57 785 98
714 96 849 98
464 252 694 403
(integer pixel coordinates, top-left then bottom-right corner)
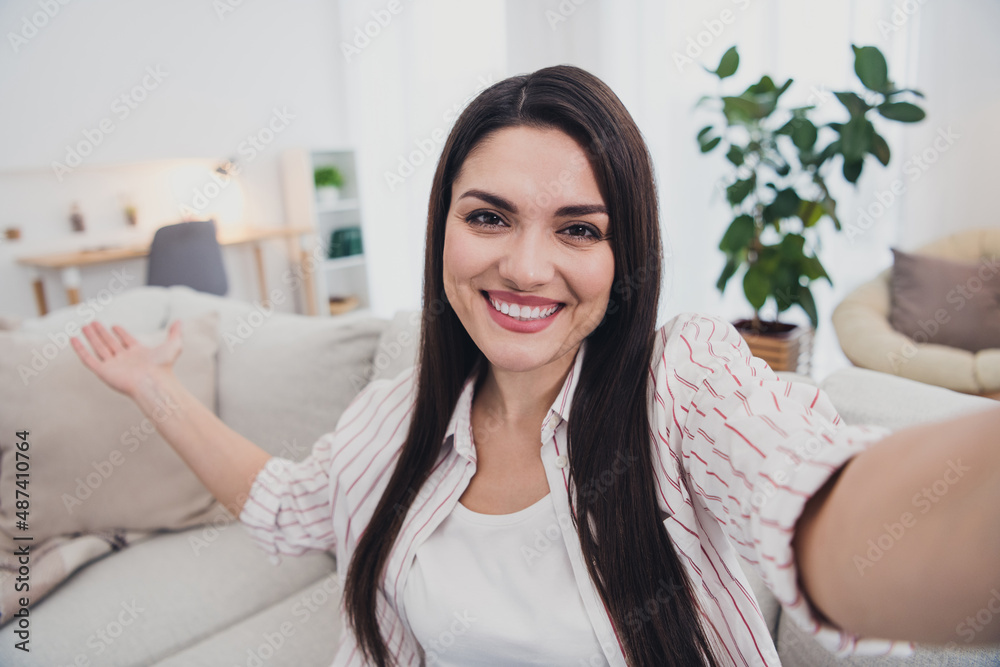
889 248 1000 352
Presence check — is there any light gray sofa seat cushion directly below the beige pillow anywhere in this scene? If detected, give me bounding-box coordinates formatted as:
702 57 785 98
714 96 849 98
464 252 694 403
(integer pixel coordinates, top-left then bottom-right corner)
0 521 334 667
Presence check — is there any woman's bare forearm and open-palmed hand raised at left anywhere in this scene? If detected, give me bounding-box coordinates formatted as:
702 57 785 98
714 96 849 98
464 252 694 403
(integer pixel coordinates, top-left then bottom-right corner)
71 322 271 516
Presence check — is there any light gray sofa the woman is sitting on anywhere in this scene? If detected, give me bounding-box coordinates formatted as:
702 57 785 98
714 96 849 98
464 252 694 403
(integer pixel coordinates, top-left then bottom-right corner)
0 287 1000 667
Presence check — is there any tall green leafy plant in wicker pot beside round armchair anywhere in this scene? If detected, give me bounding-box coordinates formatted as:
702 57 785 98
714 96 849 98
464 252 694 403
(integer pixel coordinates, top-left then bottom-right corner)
697 46 925 371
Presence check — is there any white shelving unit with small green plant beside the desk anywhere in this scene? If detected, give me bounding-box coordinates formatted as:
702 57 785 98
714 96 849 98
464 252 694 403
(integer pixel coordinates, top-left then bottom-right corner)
281 149 371 315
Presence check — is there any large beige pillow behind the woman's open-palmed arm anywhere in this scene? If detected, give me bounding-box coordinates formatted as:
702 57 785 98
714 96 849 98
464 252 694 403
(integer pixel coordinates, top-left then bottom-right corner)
0 314 227 552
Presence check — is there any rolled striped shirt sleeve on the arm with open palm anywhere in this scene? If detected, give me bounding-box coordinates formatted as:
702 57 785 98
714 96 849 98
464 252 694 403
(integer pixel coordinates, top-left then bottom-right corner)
239 380 389 564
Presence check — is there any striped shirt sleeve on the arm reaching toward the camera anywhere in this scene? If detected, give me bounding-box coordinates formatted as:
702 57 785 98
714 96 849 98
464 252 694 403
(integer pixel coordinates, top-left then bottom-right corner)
651 313 912 657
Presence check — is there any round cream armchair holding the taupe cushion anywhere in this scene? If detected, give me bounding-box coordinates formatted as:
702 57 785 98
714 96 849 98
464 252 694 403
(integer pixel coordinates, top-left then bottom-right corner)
833 228 1000 398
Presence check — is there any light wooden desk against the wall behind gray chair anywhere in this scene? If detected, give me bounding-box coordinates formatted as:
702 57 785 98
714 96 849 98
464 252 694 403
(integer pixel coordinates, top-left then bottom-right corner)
17 227 316 315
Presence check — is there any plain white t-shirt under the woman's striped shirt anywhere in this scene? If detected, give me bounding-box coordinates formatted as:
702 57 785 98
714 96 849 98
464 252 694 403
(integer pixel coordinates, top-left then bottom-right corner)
403 495 608 667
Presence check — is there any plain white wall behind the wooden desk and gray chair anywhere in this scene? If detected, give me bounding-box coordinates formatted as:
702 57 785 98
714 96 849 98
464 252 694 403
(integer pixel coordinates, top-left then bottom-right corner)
0 0 348 315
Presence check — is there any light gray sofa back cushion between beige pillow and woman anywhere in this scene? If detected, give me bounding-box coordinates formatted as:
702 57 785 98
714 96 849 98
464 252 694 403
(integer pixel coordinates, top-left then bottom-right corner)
164 287 386 460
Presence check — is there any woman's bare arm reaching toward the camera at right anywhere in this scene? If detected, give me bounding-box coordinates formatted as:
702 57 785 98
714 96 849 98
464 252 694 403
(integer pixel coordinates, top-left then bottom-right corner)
794 408 1000 643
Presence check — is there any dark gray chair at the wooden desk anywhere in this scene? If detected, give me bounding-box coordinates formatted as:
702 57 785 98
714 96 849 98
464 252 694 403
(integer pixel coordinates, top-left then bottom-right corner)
146 220 229 296
